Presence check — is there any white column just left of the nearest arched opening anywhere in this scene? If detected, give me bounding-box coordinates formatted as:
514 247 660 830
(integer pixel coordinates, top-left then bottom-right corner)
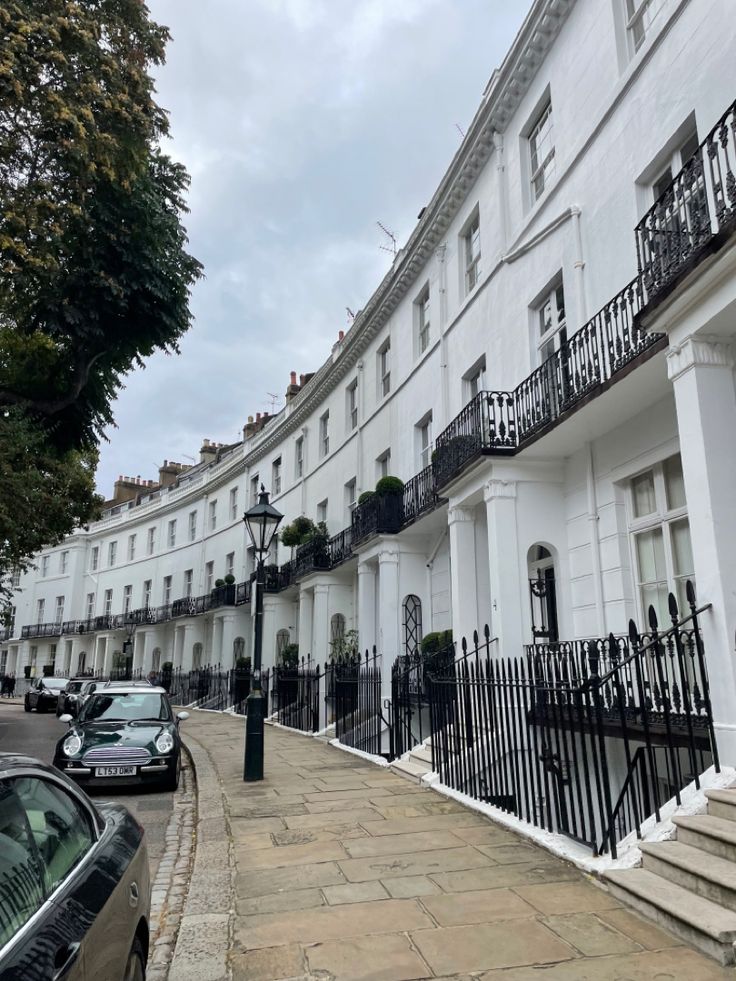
480 480 526 657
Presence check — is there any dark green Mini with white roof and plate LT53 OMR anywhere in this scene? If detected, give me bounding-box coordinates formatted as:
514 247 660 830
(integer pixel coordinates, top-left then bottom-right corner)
54 684 189 790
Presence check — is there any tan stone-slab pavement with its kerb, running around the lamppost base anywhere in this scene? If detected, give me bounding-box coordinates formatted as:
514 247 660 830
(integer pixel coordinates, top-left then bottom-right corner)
174 712 733 981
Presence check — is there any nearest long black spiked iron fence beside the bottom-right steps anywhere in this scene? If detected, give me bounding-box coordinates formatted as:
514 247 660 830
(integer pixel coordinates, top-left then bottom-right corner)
429 583 719 858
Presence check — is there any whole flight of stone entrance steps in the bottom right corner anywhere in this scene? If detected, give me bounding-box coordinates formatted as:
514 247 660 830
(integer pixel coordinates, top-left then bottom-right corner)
604 789 736 965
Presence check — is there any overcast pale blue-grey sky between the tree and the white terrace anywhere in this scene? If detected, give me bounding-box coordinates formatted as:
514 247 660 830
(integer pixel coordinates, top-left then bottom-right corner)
97 0 529 497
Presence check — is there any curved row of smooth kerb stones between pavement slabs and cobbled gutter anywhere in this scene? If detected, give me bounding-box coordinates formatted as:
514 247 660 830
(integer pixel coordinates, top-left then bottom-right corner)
167 733 235 981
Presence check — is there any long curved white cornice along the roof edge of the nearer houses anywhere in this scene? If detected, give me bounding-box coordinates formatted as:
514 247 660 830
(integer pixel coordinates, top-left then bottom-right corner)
245 0 575 466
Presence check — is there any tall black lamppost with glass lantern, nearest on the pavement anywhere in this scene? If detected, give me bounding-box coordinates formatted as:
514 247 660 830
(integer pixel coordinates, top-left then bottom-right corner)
243 484 283 782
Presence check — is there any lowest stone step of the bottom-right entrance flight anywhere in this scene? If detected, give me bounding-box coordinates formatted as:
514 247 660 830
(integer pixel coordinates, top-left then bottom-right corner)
604 869 736 965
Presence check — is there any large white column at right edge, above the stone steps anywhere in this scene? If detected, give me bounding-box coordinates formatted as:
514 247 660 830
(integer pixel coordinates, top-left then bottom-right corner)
667 337 736 766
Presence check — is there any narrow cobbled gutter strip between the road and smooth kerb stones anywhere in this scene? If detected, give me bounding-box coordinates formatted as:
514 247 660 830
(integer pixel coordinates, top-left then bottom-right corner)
146 747 197 981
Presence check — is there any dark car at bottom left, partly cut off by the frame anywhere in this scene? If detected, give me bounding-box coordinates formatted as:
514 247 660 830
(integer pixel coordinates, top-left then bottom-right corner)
0 753 151 981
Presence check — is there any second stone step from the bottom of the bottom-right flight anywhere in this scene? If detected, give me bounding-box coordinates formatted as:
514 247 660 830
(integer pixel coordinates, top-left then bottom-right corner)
639 841 736 912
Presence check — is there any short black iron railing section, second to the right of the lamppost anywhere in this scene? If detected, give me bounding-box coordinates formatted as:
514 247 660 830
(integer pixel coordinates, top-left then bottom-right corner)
331 647 386 755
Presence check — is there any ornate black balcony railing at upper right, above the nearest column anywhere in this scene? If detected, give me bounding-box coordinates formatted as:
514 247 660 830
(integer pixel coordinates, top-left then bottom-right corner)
636 103 736 301
